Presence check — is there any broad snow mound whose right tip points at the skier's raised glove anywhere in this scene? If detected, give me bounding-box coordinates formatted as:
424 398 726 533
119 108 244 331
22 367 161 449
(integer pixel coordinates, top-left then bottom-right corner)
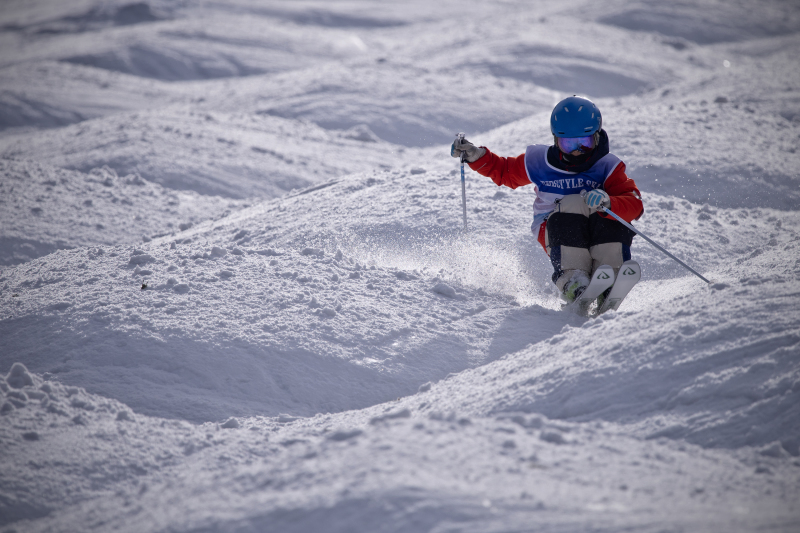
0 105 406 199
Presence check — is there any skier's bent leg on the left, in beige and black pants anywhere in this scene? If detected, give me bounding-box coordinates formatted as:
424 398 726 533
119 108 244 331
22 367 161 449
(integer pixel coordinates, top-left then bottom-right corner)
545 194 592 293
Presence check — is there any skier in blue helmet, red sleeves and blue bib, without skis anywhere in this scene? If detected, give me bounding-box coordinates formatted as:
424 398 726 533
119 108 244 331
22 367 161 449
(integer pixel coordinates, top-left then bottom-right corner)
450 96 644 302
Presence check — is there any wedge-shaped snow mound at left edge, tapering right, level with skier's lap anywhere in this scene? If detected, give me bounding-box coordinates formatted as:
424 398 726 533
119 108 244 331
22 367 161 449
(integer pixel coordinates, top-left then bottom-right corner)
0 159 242 265
